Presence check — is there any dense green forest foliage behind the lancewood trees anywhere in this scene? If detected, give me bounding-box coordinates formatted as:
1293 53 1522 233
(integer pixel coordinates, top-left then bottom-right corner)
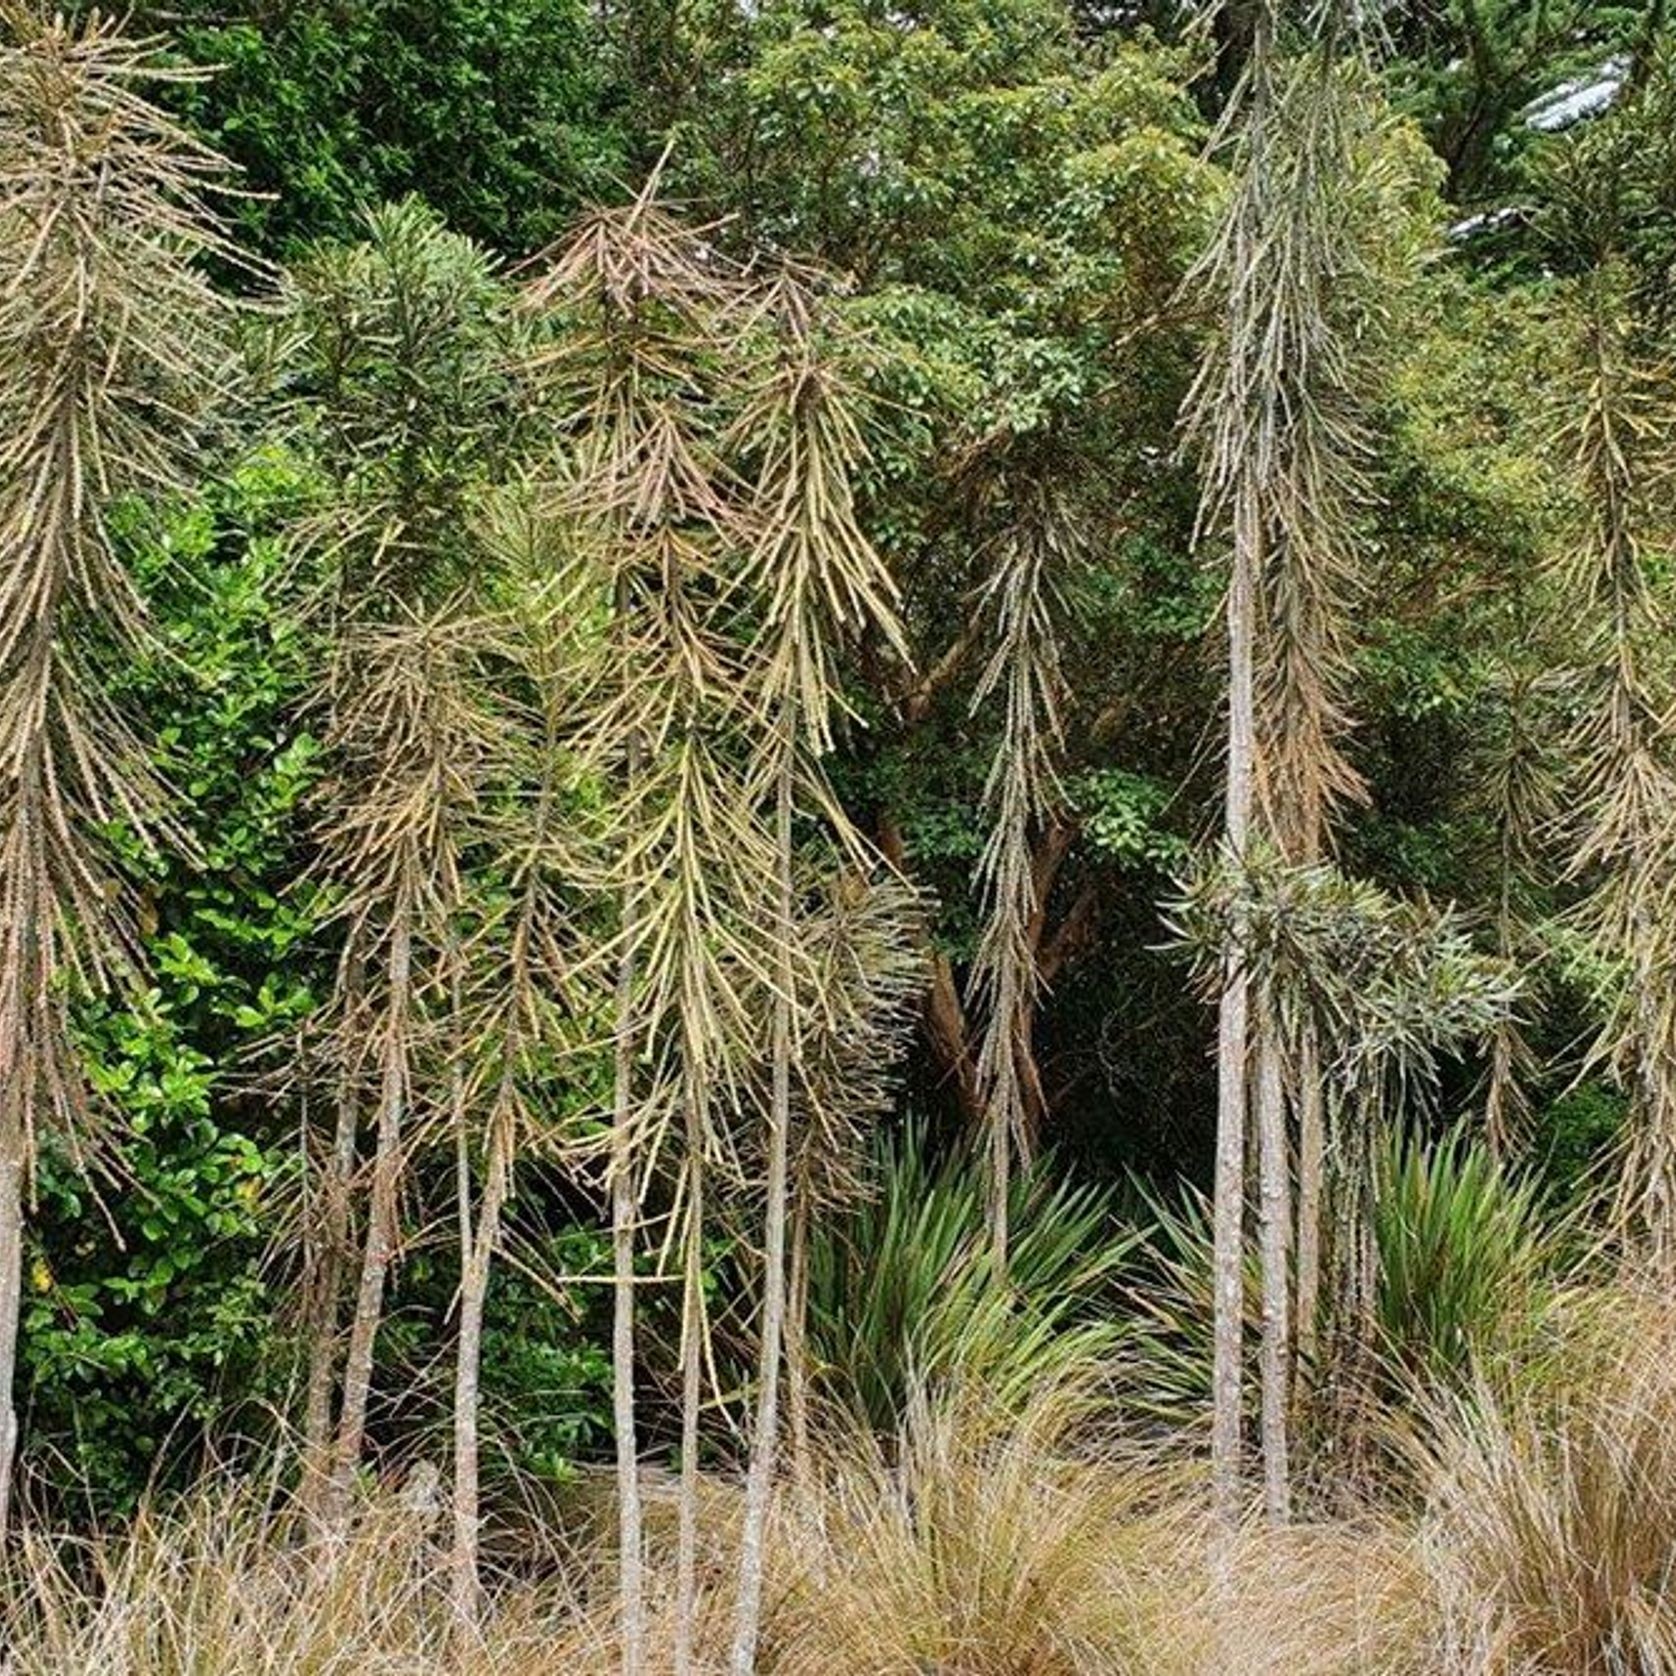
3 0 1668 1505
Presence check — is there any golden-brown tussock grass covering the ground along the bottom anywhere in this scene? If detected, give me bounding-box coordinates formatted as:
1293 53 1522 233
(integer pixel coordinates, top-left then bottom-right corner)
19 1320 1676 1676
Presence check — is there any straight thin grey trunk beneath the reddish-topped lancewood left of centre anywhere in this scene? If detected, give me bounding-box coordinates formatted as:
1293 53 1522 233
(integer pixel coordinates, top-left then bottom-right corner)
612 864 645 1676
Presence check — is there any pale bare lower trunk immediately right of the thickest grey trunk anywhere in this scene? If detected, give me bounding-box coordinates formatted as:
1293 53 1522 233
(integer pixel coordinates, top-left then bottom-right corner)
1257 1007 1292 1525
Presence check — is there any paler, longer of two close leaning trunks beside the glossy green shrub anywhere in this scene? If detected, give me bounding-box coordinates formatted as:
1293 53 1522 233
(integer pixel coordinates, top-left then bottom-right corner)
327 907 412 1534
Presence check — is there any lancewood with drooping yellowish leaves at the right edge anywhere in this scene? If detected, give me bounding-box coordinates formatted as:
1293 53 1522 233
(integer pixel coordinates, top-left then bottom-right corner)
1549 121 1676 1264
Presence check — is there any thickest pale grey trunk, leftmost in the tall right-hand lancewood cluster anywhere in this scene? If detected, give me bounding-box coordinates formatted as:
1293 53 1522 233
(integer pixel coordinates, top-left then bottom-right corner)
1210 489 1259 1530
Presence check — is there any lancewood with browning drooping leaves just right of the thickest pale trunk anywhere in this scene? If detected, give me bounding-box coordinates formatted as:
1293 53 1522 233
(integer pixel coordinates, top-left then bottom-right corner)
1255 36 1393 1414
